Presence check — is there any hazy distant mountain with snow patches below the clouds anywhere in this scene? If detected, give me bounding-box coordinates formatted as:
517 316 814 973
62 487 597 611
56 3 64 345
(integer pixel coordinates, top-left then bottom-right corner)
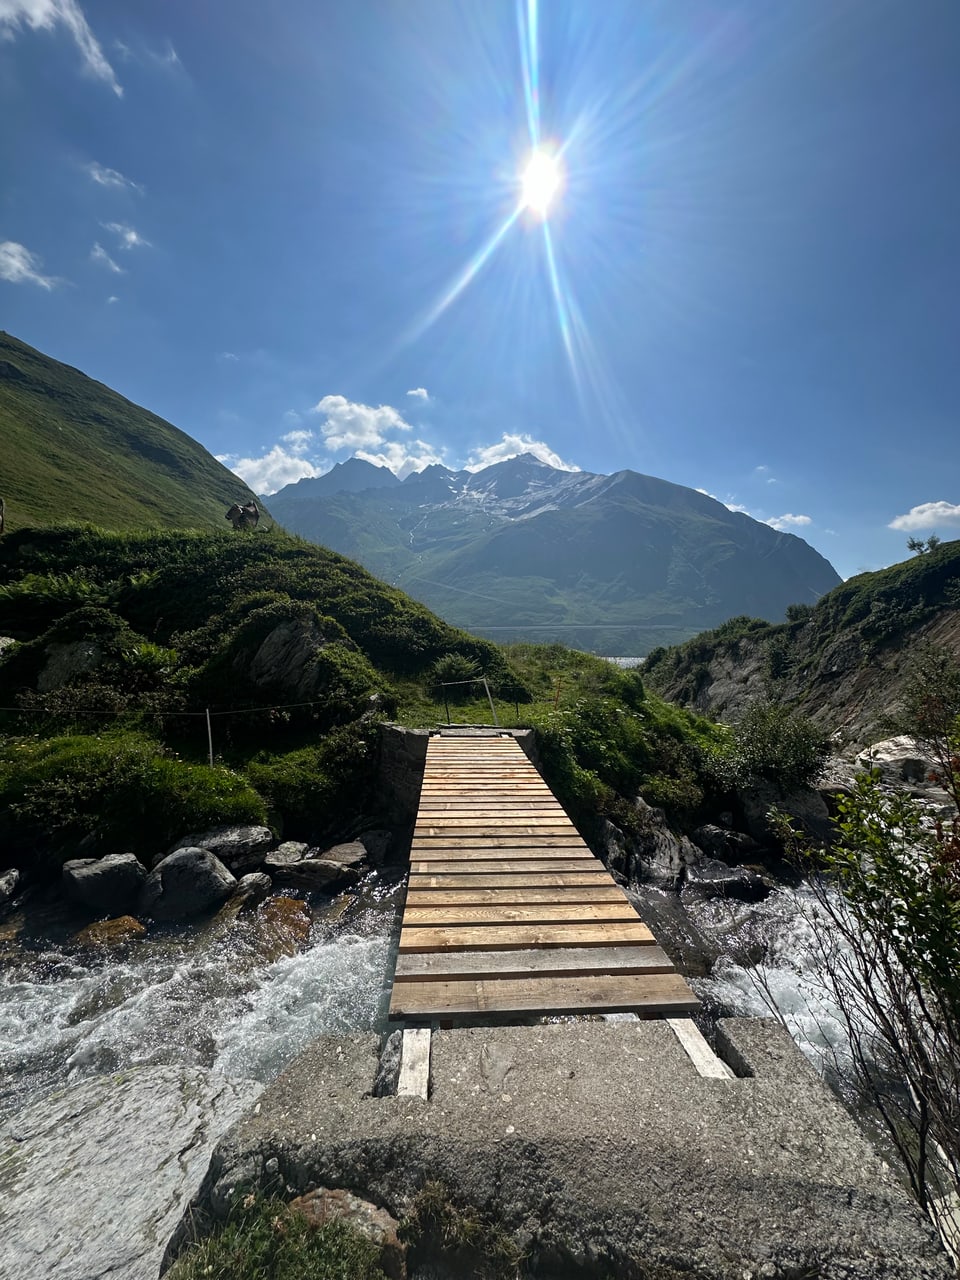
268 454 841 655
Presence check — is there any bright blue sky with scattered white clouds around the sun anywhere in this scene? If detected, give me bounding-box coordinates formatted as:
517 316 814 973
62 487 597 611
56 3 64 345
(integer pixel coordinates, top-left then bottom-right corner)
0 0 960 576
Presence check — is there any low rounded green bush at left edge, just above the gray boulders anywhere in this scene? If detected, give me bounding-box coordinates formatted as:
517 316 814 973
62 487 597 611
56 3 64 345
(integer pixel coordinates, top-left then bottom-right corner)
0 730 266 864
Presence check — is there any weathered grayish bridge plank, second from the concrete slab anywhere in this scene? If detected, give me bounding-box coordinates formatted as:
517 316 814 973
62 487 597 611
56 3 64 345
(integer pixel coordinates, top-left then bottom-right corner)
394 943 675 982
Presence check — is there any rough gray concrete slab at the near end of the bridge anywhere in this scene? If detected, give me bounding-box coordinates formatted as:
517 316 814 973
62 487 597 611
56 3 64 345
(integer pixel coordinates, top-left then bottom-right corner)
172 1019 951 1280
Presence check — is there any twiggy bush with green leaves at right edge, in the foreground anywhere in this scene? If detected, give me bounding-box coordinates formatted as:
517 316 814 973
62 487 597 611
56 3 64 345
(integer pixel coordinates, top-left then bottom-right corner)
771 757 960 1262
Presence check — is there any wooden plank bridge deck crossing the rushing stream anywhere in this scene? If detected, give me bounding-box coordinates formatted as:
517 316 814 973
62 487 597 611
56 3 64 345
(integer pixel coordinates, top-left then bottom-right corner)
390 736 698 1023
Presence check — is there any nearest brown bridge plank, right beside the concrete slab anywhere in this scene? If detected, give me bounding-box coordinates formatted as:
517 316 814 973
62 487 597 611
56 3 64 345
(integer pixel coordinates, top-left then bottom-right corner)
390 973 700 1018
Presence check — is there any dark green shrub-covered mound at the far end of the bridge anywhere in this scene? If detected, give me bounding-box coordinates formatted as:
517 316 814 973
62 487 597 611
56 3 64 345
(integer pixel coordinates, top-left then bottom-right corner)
0 526 727 869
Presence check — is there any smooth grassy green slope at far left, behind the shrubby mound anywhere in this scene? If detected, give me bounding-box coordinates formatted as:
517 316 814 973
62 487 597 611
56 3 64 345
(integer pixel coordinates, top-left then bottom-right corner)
0 333 263 531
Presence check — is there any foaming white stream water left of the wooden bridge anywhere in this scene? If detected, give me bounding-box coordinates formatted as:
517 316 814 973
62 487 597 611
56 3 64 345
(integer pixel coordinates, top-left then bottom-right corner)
0 877 396 1114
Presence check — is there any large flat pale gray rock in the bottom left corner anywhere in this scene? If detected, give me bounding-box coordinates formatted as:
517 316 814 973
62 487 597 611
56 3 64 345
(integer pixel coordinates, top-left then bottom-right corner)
0 1066 260 1280
